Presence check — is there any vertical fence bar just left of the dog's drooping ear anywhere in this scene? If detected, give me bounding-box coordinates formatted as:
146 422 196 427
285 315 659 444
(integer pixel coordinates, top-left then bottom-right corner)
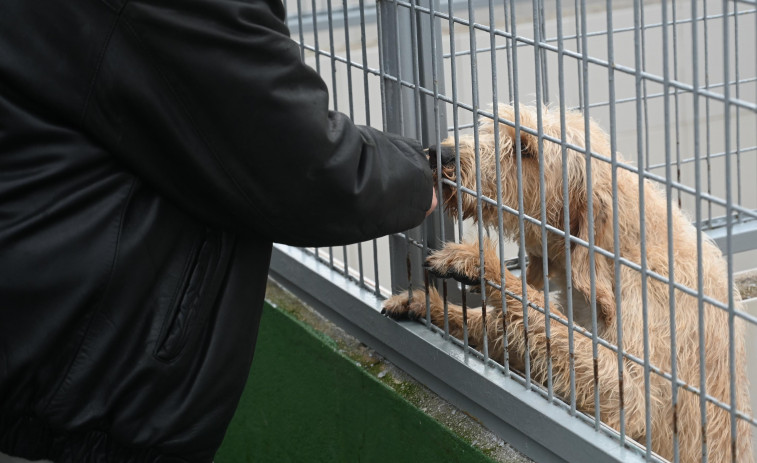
556 0 576 415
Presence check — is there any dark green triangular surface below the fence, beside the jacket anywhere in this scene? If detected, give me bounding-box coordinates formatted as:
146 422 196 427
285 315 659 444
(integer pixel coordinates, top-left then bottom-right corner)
215 304 493 463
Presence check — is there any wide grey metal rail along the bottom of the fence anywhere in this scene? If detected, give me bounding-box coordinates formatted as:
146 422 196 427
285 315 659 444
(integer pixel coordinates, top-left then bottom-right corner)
271 245 662 463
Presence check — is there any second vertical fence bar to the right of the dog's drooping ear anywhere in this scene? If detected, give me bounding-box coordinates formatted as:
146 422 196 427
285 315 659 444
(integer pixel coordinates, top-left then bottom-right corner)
634 0 652 460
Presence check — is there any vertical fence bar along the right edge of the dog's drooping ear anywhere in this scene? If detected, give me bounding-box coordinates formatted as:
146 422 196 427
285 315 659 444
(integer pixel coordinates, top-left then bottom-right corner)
605 0 626 445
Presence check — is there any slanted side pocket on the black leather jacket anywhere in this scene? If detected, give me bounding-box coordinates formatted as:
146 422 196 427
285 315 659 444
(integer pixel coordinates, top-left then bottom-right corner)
153 230 230 362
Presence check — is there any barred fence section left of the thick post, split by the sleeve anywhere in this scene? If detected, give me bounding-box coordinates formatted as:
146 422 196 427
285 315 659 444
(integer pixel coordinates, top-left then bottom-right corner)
285 0 391 295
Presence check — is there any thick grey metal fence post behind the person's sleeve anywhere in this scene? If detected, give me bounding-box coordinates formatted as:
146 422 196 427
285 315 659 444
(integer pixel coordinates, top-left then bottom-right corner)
377 0 453 292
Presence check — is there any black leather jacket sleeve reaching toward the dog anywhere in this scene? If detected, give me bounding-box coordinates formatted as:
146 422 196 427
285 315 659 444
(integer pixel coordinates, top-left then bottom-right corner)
84 0 432 246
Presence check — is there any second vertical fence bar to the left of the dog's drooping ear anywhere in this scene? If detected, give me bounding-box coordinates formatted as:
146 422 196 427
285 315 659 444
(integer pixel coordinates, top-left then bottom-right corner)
531 1 554 402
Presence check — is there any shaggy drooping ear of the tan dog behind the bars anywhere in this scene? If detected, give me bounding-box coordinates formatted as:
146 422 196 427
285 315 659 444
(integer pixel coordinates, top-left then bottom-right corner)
570 185 615 324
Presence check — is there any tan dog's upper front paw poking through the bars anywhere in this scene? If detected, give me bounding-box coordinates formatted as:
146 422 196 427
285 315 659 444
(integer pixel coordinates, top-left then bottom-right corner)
426 243 481 286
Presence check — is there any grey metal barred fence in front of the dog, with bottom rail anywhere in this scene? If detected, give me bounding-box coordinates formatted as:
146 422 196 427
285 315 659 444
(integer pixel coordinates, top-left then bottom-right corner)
272 0 757 461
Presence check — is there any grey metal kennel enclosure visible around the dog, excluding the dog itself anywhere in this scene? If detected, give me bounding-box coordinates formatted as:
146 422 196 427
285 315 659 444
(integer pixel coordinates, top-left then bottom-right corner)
272 0 757 461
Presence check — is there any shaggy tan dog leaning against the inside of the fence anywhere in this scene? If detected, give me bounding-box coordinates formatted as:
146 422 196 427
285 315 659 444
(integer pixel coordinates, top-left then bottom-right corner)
384 105 752 462
